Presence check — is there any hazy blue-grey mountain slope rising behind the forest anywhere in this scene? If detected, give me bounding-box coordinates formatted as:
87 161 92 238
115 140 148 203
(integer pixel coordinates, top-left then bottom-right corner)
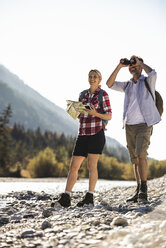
0 65 129 162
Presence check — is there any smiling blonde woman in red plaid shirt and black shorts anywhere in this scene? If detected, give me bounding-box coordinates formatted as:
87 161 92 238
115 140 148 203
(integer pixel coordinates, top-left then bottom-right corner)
52 70 111 207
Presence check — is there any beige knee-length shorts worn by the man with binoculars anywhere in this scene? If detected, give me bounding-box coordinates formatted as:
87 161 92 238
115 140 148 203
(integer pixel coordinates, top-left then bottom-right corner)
126 123 153 164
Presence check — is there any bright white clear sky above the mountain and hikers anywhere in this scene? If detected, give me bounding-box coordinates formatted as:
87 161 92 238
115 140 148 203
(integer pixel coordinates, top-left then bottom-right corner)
0 0 166 160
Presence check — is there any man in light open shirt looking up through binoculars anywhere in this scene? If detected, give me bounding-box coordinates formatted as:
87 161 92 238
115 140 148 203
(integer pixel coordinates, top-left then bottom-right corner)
106 56 161 202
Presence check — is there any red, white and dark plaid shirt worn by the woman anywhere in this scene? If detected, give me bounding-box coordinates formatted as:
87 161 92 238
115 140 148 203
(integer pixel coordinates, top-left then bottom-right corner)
79 88 112 135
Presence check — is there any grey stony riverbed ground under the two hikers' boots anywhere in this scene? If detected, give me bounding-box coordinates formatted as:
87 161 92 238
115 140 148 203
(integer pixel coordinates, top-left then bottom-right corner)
0 176 166 248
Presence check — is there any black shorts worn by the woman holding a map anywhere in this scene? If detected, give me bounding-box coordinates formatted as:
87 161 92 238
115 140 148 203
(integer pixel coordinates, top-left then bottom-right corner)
73 129 105 157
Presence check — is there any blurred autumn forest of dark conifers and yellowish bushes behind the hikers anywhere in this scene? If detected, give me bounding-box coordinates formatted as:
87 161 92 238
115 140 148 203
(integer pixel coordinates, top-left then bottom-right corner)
0 104 166 180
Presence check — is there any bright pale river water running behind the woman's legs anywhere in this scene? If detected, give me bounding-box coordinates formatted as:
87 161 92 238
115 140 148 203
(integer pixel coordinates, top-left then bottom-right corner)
0 177 135 194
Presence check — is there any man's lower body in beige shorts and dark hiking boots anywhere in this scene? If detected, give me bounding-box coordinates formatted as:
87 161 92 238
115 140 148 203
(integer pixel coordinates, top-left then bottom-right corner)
126 124 152 201
